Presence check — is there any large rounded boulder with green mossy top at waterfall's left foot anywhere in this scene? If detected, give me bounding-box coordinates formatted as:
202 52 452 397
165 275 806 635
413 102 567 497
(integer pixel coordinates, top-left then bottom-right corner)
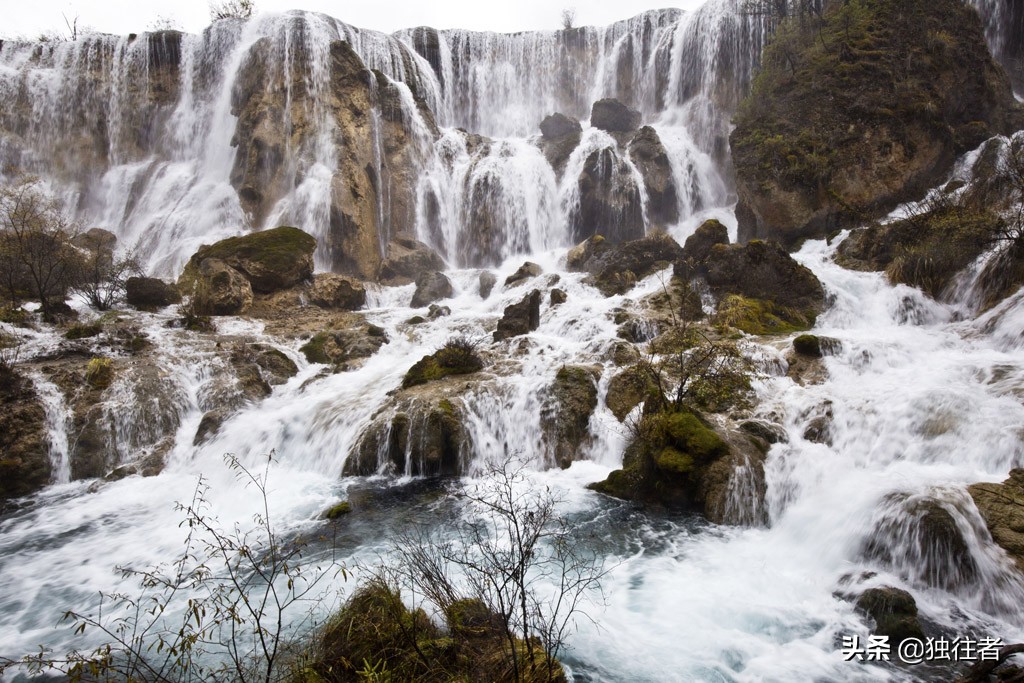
179 226 316 294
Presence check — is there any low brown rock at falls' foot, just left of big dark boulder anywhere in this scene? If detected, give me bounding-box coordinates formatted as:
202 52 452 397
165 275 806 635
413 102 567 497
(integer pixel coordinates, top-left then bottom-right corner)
567 232 682 296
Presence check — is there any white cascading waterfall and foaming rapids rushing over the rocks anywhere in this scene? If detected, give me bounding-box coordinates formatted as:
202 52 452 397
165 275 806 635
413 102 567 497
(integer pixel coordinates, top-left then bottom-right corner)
0 0 1024 681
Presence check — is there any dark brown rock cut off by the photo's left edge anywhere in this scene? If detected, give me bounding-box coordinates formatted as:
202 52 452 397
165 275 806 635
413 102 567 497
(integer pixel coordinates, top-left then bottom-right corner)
0 369 51 502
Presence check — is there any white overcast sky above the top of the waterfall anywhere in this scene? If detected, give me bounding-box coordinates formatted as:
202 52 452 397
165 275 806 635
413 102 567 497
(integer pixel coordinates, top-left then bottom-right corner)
0 0 703 38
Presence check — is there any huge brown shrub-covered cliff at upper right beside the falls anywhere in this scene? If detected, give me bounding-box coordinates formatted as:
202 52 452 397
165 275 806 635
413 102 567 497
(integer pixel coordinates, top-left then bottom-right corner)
731 0 1021 246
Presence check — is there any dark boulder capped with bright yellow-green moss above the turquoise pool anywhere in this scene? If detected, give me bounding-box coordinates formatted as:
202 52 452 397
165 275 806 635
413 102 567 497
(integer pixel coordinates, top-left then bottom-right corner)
590 409 729 510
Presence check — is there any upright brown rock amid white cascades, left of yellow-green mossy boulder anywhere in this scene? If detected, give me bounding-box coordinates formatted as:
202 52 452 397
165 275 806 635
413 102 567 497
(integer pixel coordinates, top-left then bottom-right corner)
541 366 601 469
